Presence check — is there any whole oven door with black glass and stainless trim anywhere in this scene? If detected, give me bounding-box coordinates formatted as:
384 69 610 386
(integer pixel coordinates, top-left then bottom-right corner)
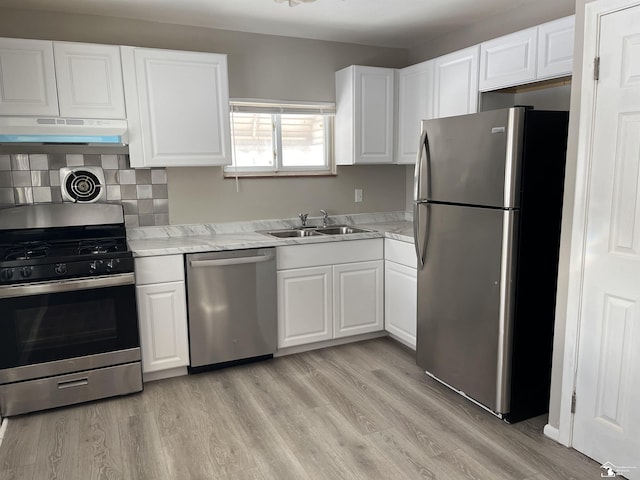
0 273 140 383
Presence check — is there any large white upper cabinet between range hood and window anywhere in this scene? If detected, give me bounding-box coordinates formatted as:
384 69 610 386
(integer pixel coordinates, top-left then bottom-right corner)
122 47 231 167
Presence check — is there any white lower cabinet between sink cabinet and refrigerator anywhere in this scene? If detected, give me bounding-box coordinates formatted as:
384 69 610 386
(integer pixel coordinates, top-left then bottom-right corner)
384 239 418 349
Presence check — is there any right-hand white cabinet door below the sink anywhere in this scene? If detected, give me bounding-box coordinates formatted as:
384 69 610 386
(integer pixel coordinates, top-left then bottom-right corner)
333 260 384 338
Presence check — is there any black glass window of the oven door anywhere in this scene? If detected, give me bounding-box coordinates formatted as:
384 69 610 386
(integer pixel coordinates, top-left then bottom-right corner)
0 285 140 368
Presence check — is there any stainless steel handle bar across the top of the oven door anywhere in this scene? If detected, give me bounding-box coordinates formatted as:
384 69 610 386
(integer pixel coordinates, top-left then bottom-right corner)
0 273 135 298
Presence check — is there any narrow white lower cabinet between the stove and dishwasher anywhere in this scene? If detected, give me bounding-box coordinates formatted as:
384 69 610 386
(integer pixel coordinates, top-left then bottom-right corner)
135 255 189 373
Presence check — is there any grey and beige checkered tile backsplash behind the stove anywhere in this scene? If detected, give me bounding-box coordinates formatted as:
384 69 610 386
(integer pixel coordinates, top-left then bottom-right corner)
0 153 169 227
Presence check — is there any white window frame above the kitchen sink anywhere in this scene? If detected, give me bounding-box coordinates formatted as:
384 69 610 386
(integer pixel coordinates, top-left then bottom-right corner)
223 99 336 178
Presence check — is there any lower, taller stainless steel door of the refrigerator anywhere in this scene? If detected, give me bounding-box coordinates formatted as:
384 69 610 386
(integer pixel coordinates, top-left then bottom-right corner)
416 204 518 413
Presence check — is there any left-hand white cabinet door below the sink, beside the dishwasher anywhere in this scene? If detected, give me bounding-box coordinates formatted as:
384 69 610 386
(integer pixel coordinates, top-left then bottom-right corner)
278 266 333 348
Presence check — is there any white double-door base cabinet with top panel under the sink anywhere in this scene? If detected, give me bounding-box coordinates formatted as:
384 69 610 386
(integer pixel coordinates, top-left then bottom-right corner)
277 239 384 348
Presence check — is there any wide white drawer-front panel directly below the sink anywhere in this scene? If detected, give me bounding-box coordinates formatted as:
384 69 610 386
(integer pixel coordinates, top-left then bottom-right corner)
277 238 384 270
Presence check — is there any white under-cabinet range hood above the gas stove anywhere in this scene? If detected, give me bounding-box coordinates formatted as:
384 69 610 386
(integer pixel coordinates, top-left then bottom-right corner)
0 117 129 147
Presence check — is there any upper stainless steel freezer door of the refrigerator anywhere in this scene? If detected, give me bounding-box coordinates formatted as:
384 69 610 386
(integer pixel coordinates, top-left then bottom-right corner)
414 107 525 208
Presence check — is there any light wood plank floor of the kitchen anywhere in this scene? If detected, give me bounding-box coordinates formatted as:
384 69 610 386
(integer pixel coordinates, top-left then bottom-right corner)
0 338 600 480
